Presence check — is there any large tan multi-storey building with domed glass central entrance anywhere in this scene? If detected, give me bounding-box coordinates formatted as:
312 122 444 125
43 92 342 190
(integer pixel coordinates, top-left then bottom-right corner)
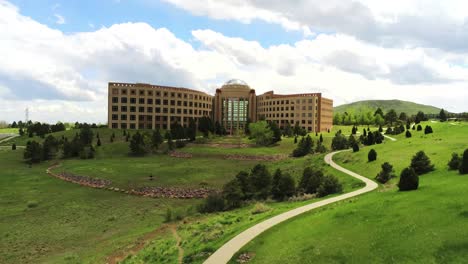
108 80 333 134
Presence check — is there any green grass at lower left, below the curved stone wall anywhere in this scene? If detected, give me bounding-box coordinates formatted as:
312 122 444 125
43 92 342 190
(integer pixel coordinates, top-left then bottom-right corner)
0 150 195 263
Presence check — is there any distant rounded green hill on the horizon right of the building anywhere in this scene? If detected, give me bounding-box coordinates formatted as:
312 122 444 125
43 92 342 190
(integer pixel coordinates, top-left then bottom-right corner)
334 100 440 115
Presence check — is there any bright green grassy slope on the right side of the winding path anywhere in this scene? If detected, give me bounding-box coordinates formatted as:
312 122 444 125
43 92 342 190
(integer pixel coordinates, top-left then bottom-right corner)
236 123 468 263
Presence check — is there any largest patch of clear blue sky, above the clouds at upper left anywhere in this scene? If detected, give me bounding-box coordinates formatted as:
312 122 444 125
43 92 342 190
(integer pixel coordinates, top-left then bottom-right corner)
11 0 304 47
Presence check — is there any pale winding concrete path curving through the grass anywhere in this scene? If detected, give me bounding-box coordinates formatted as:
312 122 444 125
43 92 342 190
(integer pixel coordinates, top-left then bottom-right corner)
204 150 378 264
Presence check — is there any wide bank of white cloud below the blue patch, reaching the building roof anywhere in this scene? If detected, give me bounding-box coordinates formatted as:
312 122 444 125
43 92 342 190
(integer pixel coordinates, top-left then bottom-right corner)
0 0 468 122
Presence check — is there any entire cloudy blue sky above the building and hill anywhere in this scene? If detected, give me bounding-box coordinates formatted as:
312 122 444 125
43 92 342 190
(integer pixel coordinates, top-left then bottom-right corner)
0 0 468 123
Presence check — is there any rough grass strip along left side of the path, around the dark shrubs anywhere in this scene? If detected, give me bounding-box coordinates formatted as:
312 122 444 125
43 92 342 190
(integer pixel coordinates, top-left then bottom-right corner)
121 155 361 263
